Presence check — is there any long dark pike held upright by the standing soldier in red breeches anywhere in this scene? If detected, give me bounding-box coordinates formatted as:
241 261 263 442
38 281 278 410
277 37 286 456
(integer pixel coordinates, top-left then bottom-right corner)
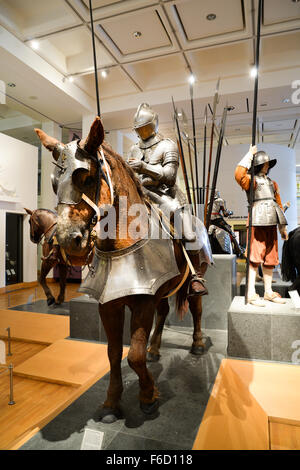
245 0 263 305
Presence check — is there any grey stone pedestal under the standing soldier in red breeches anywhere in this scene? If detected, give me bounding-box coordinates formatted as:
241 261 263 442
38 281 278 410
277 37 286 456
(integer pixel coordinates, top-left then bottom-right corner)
227 297 300 362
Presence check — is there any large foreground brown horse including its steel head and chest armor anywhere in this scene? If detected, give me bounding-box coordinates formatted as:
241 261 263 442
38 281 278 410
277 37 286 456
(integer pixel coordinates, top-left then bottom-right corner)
36 117 212 423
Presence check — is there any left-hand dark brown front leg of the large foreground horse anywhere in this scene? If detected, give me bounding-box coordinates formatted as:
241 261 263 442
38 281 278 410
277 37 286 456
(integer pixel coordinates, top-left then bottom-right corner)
99 305 125 423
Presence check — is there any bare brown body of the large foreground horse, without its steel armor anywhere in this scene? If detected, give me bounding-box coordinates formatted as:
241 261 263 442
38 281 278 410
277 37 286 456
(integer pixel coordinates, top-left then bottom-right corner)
36 118 209 422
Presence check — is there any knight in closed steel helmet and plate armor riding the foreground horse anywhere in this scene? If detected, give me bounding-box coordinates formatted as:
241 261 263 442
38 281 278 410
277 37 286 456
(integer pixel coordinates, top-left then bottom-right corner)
128 103 210 295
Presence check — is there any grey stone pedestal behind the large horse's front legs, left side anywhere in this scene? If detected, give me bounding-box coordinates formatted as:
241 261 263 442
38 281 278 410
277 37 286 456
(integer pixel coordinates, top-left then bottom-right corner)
70 295 130 345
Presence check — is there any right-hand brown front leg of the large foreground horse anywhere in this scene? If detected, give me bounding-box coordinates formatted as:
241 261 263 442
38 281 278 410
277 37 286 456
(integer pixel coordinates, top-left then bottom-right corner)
127 296 158 414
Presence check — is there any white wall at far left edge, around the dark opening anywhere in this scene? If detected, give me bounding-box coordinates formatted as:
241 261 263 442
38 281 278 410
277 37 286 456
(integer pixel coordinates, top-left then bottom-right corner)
0 133 38 288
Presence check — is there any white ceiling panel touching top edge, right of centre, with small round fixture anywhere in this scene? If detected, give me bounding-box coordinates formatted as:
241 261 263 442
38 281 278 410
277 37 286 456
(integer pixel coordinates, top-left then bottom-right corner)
175 0 244 41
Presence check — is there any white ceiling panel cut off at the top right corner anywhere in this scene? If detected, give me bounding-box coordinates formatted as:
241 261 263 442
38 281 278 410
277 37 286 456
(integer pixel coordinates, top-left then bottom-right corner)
263 0 300 26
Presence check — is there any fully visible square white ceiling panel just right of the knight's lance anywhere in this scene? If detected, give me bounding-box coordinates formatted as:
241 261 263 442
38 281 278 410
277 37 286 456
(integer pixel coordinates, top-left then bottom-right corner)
99 9 172 56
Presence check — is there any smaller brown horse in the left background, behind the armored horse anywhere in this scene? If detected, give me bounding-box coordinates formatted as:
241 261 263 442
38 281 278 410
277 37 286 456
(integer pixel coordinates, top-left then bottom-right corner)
25 208 92 305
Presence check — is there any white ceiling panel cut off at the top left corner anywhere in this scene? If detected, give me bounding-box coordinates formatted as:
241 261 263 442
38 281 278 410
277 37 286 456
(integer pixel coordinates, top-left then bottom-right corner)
0 0 80 39
